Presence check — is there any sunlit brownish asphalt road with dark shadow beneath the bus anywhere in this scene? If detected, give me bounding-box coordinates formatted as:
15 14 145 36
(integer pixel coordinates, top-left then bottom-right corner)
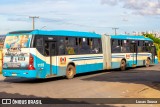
0 64 160 106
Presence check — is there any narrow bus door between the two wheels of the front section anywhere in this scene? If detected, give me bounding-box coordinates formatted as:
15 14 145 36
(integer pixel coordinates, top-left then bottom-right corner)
131 43 137 67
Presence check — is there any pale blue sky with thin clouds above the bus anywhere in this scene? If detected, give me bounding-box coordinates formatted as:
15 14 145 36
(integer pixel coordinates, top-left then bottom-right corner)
0 0 160 34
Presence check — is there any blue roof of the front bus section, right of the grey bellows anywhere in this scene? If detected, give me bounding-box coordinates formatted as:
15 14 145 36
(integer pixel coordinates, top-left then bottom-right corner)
111 35 153 41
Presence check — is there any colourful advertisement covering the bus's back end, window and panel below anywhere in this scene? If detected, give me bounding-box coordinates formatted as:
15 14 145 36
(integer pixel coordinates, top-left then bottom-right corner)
3 35 31 69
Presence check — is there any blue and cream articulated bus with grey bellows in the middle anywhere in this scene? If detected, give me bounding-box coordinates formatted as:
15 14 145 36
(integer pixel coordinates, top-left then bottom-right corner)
2 30 158 79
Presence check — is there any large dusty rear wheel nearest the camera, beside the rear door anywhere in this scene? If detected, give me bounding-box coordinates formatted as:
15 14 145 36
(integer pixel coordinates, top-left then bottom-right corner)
66 65 76 79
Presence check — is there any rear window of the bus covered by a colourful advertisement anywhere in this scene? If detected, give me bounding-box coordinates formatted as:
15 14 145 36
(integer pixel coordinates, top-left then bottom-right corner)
4 35 31 49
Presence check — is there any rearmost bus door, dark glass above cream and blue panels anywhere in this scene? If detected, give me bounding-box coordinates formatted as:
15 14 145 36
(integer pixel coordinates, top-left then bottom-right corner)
46 41 57 76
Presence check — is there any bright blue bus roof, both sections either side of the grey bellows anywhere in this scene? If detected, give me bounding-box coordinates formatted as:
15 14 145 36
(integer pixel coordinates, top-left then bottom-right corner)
8 30 153 41
